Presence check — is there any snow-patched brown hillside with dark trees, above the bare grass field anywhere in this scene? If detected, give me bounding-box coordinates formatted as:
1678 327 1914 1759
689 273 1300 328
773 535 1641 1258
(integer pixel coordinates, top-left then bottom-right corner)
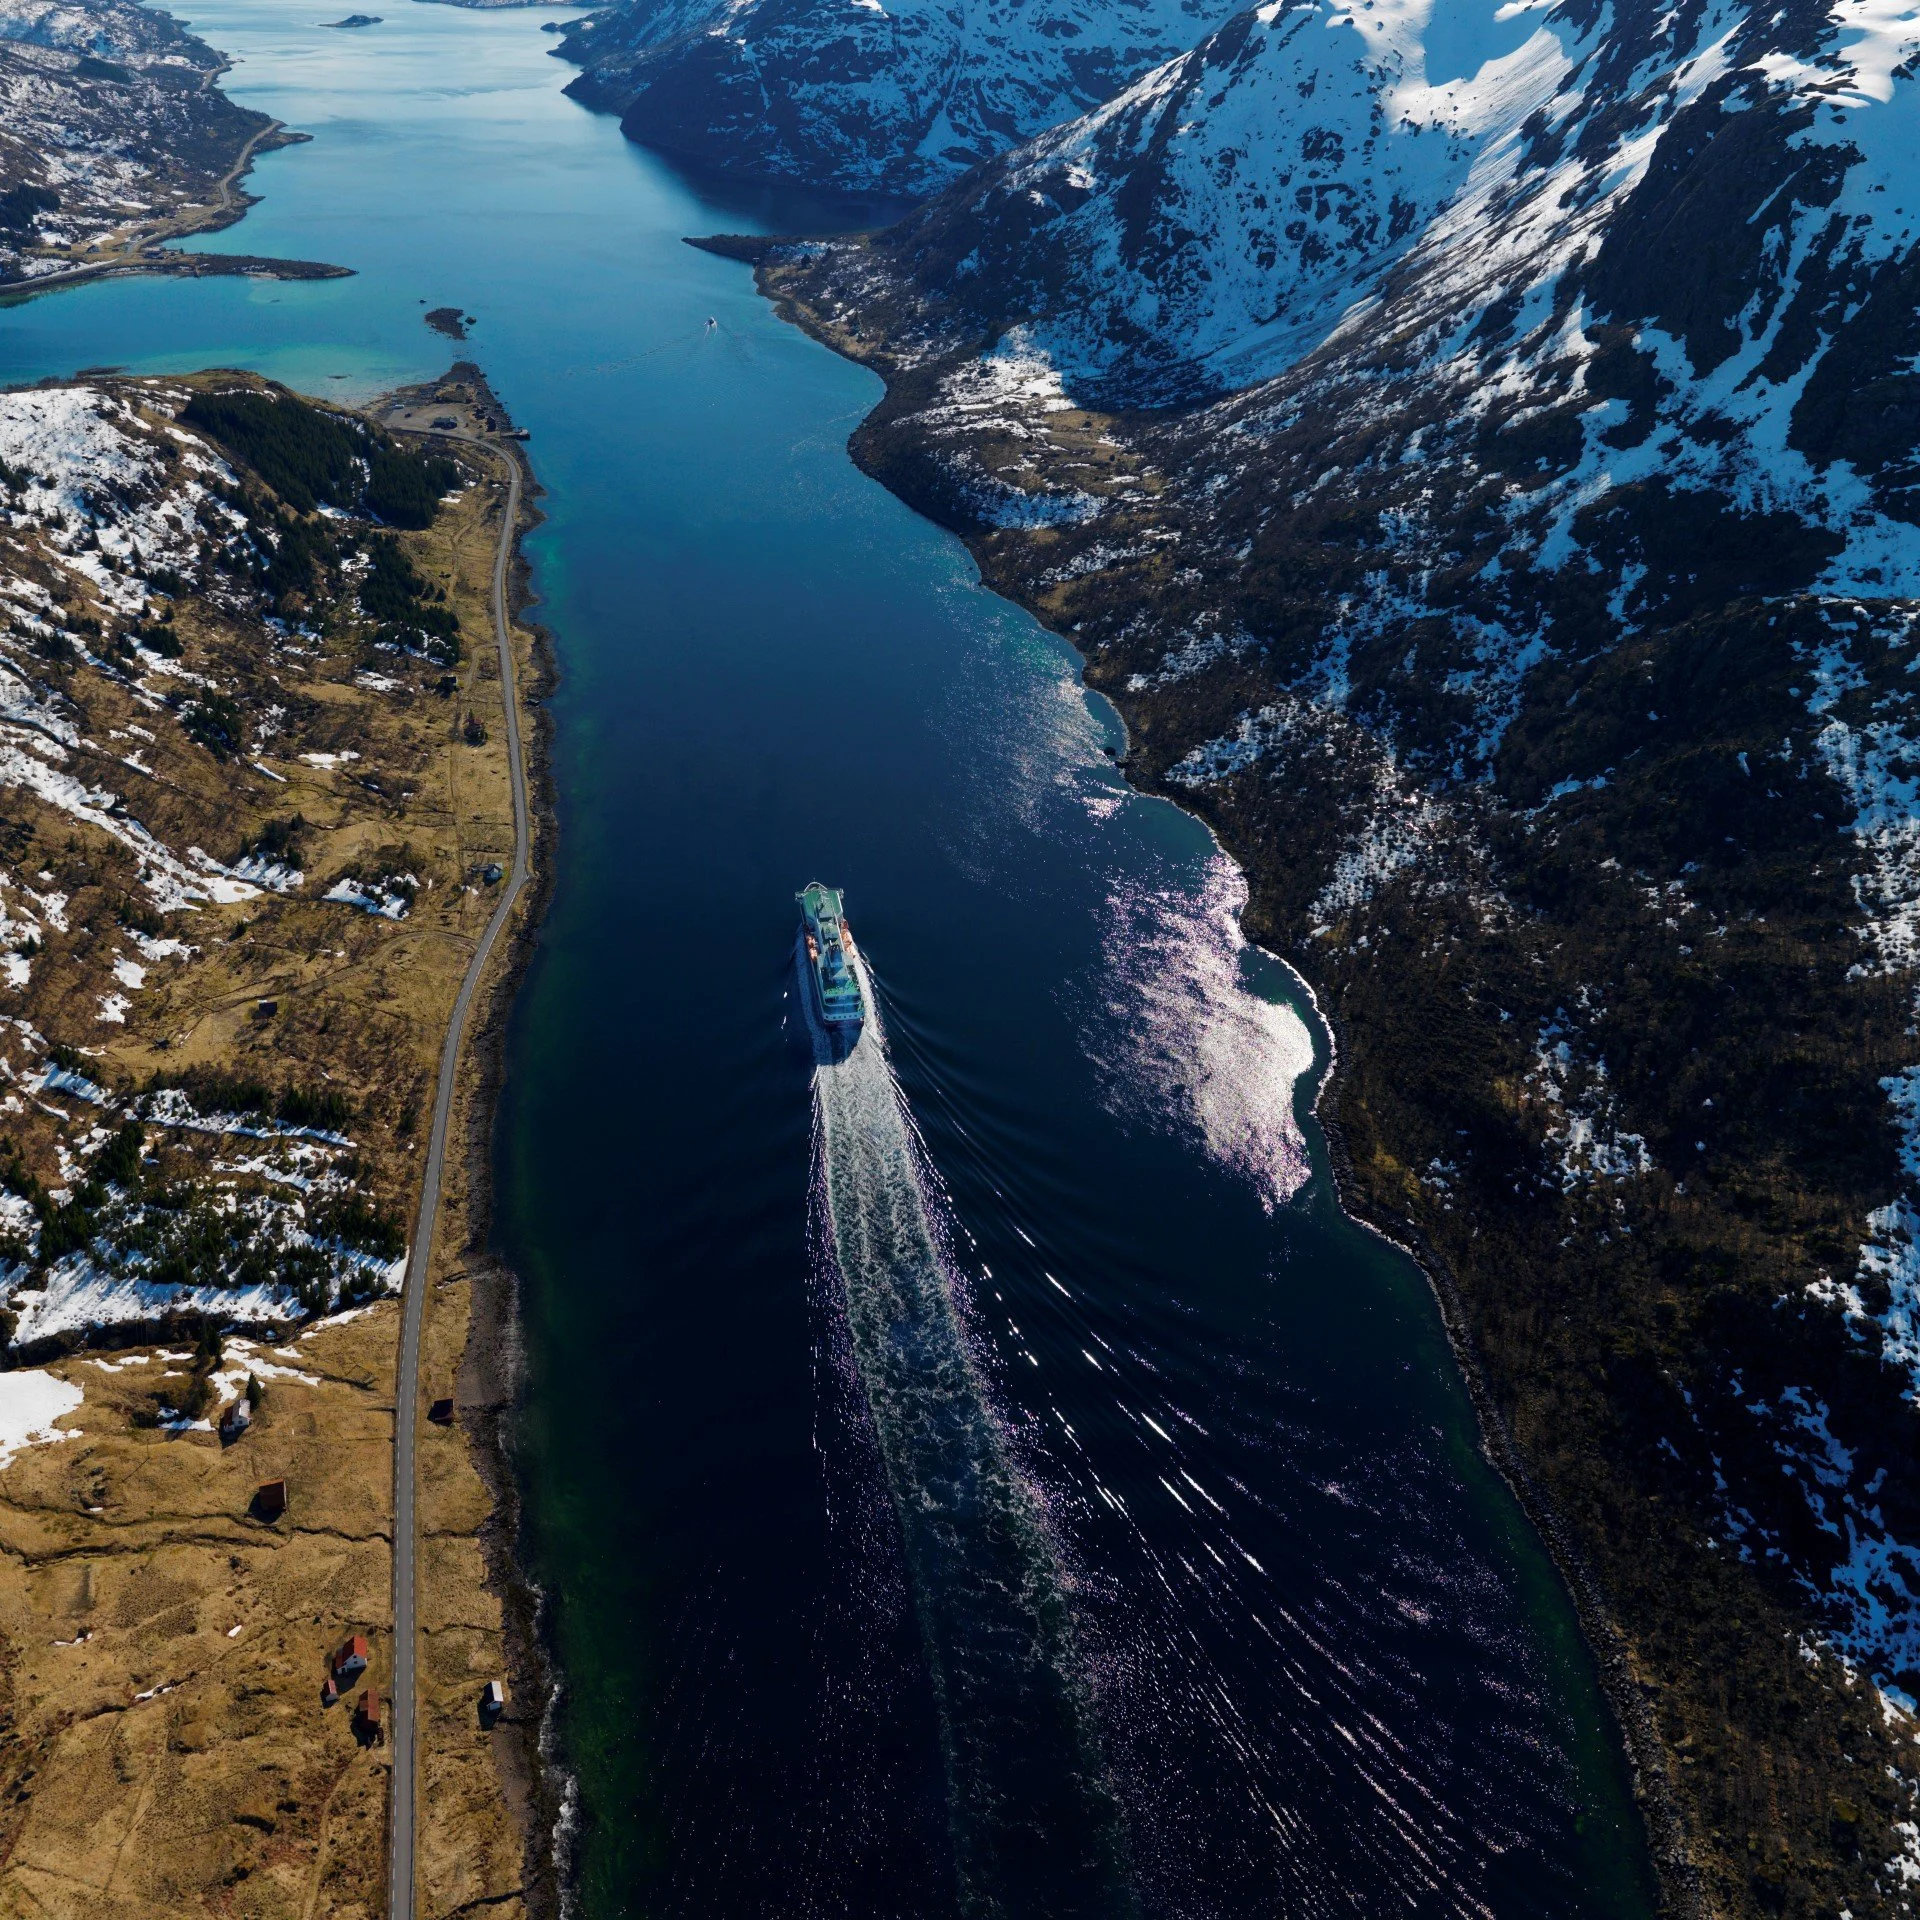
0 376 506 1359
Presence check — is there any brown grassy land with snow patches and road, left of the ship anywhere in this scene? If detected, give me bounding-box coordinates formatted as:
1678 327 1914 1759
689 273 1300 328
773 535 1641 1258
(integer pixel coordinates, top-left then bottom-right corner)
0 369 541 1916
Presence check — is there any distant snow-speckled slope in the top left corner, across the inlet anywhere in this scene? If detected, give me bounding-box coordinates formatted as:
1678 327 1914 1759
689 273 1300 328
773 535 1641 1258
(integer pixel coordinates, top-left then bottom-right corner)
0 0 288 282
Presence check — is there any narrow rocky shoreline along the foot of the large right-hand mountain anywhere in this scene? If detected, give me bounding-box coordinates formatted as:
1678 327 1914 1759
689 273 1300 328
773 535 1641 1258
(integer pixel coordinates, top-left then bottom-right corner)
733 234 1709 1920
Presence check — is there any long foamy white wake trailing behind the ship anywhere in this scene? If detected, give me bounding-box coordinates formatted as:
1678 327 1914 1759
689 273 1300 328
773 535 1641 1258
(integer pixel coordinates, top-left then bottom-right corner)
814 970 1131 1916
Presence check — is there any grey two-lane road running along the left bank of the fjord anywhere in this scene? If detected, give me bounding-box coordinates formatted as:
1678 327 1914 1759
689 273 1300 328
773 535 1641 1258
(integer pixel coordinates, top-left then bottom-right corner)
388 434 528 1920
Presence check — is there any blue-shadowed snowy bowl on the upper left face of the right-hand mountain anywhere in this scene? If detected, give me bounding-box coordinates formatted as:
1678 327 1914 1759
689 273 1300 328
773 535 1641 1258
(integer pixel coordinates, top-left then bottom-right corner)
840 0 1543 397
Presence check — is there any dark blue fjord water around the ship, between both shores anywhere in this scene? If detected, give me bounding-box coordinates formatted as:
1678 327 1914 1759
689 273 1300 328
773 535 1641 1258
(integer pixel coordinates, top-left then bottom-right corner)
0 0 1651 1920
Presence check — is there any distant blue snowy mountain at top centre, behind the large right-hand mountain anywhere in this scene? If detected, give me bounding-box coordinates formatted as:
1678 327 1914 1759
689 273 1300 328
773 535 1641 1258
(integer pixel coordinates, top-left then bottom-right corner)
559 0 1229 194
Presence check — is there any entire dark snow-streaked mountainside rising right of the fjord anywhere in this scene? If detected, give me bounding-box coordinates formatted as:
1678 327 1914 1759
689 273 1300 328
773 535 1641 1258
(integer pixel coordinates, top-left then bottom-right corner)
718 0 1920 1920
